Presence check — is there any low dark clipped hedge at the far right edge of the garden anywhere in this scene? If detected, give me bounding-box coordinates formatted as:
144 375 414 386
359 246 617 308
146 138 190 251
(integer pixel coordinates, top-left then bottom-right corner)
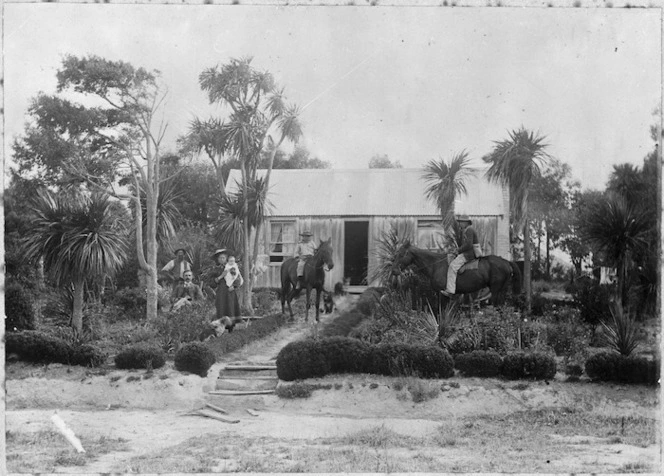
585 352 660 385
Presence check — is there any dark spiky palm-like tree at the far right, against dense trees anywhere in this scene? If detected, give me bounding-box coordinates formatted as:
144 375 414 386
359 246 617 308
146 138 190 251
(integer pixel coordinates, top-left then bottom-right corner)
579 193 652 303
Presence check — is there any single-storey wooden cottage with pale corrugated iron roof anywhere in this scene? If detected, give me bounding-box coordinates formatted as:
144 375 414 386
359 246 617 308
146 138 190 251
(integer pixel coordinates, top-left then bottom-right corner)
226 169 510 289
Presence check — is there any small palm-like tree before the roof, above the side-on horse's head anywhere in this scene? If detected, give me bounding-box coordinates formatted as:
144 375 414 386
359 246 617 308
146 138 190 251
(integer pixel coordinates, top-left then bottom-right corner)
423 150 476 230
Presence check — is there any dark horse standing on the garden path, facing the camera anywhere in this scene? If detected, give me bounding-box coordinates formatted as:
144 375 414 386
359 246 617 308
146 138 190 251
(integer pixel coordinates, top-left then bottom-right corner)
281 238 334 322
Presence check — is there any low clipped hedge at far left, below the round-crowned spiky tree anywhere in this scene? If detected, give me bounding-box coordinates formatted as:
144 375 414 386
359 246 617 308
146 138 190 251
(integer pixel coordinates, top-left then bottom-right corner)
5 331 107 367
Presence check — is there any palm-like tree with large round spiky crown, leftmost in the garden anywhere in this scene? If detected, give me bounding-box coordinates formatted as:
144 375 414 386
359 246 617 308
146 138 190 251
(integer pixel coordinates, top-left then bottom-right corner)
24 190 128 335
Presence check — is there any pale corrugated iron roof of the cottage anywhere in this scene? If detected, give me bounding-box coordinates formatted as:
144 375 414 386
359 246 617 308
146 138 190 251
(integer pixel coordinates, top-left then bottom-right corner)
226 169 508 216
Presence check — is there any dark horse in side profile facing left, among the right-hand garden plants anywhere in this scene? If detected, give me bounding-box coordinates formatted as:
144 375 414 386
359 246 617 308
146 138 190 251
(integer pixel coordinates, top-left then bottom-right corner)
392 241 521 304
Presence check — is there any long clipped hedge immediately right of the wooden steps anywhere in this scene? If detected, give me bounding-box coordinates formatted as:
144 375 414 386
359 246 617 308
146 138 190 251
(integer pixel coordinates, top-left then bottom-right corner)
277 337 454 381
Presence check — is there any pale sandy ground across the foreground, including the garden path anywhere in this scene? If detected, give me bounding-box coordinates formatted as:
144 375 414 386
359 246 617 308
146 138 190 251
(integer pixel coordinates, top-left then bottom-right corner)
6 308 662 473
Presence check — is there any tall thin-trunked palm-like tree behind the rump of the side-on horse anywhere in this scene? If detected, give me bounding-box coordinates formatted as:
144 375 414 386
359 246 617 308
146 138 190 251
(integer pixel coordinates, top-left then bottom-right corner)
484 127 550 313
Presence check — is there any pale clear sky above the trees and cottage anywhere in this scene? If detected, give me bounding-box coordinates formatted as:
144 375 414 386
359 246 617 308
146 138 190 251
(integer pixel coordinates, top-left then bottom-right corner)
3 3 662 189
